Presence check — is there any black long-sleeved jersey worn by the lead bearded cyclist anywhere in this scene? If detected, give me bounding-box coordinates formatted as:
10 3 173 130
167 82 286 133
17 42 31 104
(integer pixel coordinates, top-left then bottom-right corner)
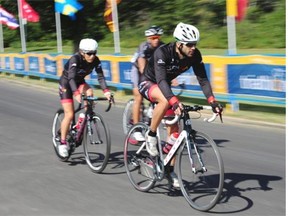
140 42 214 101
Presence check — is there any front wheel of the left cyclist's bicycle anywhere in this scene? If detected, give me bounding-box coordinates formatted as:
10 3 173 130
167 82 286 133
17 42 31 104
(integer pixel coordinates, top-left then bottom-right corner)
82 113 111 173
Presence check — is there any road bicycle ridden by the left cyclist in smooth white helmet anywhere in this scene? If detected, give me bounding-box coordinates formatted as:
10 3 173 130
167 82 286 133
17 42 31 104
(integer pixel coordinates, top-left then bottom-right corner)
52 95 114 173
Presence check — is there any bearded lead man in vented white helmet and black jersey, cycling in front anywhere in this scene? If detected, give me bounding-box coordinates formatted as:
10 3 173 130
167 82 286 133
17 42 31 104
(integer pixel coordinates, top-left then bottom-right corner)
138 22 223 187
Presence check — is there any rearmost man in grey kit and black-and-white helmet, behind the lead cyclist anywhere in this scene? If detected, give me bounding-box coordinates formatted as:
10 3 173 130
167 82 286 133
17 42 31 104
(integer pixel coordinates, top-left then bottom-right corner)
131 25 164 141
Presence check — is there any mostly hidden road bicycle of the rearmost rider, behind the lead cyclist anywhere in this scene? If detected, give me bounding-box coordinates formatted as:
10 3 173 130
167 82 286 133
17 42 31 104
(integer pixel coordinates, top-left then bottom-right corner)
122 83 186 135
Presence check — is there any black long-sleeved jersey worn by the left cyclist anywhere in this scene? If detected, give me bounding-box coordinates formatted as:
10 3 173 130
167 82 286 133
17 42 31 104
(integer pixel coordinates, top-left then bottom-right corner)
59 52 107 93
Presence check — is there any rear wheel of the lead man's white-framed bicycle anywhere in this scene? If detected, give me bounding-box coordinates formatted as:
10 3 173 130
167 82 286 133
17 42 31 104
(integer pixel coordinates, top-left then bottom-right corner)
124 122 156 192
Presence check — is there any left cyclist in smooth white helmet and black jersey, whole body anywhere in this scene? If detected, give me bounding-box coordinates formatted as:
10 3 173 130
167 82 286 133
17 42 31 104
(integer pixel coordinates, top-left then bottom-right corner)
58 38 111 157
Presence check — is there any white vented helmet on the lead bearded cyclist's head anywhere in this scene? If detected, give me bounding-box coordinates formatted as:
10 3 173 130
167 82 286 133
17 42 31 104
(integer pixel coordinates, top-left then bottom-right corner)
173 22 200 44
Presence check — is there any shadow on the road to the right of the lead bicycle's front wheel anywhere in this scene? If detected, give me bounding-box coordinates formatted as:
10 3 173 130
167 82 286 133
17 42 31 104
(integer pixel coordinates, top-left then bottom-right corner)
209 173 282 214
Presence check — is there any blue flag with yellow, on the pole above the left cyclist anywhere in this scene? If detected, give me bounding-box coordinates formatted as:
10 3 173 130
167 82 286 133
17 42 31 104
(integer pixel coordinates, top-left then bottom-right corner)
55 0 83 20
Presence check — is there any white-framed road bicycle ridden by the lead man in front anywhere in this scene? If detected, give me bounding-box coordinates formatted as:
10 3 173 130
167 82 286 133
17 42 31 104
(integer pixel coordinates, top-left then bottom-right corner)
124 105 224 211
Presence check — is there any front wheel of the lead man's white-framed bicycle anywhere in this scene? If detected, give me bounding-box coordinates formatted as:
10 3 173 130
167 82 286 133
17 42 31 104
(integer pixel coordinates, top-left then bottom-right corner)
177 132 224 211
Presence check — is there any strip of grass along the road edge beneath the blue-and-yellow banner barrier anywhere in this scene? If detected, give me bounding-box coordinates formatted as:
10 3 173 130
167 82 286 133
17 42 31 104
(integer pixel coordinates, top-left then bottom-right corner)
0 72 286 125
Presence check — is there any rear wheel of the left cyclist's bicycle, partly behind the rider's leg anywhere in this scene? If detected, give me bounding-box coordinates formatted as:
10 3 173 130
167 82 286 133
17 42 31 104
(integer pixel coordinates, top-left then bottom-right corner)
52 109 71 162
